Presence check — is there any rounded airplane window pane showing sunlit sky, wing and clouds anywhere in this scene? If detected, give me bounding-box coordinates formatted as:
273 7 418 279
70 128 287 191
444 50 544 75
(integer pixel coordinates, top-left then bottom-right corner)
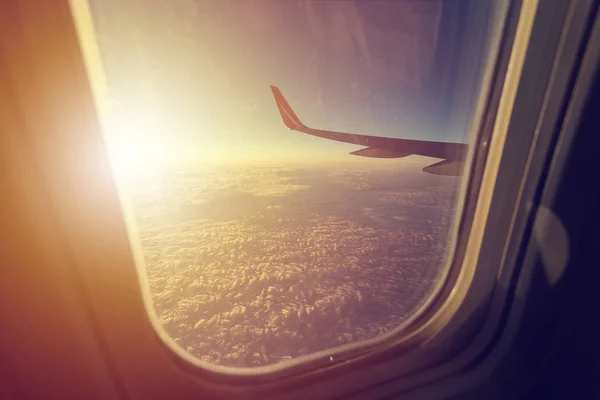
90 0 502 368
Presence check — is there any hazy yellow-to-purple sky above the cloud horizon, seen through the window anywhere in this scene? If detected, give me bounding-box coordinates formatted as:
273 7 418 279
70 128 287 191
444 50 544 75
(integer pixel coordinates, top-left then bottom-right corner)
91 0 492 169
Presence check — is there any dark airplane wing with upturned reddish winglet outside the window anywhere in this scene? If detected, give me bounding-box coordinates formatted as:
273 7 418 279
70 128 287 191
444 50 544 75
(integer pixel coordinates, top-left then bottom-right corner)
271 85 468 176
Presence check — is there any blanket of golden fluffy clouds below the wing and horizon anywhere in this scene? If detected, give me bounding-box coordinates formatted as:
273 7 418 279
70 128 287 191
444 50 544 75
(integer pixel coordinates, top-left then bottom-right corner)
132 164 454 367
